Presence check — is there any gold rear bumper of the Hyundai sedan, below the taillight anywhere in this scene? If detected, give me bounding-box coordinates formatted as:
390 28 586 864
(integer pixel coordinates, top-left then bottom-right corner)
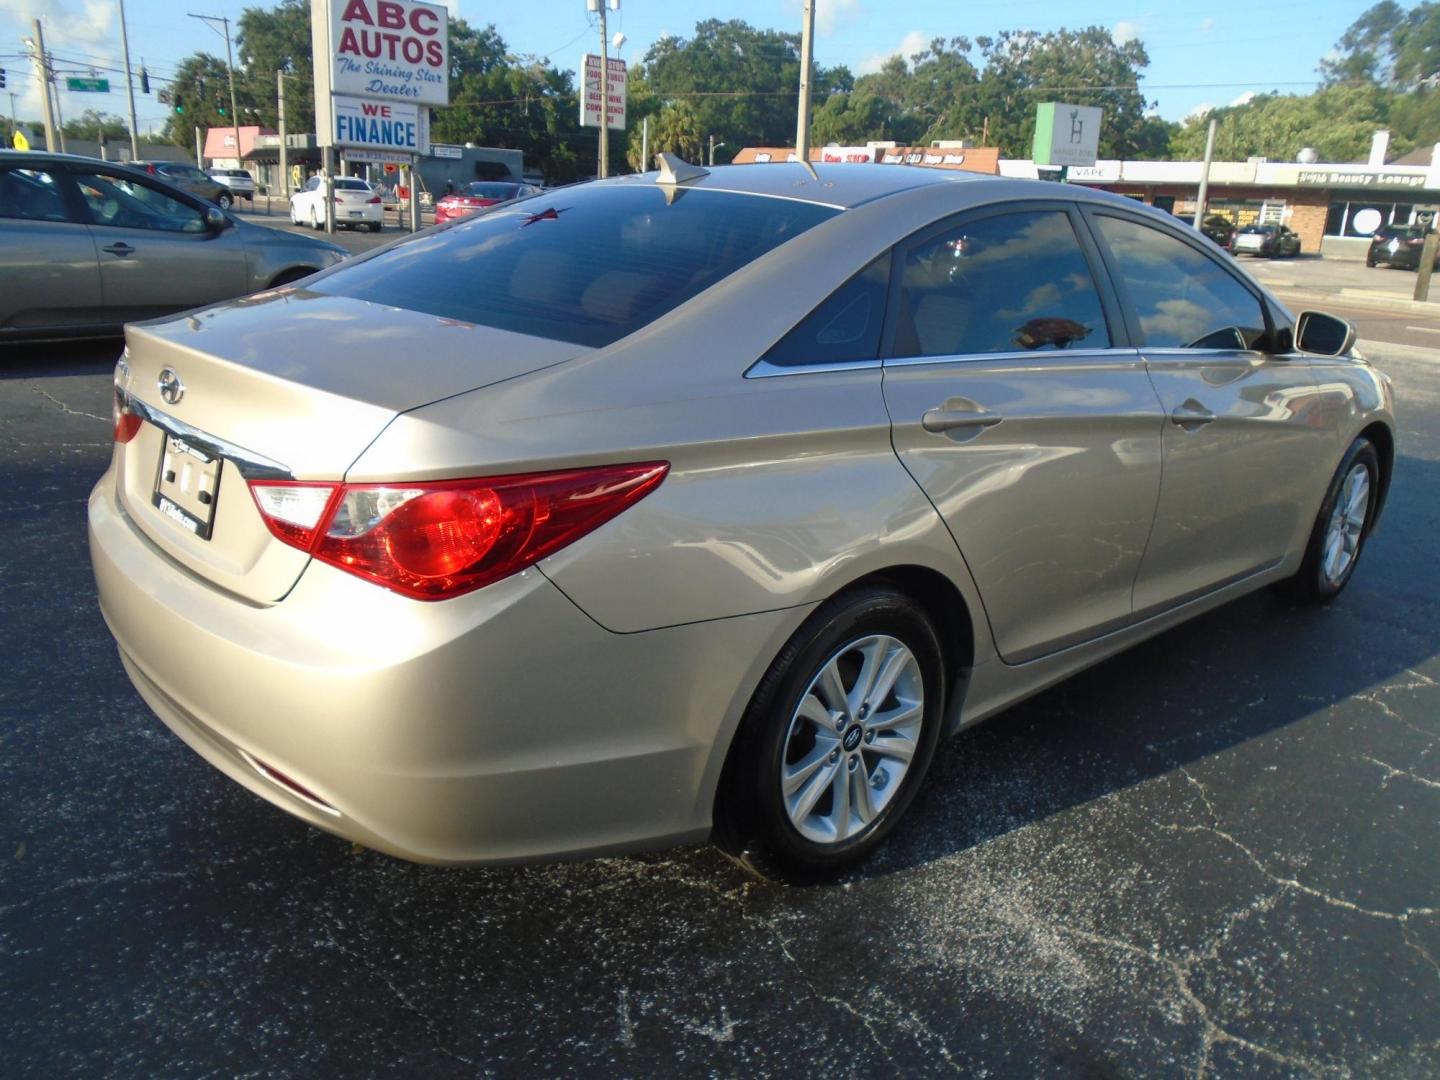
89 472 805 864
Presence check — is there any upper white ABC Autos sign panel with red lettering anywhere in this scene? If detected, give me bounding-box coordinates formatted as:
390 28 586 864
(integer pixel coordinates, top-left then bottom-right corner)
311 0 449 105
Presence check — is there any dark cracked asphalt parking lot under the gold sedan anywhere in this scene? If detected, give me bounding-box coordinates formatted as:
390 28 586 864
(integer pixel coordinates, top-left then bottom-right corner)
0 262 1440 1077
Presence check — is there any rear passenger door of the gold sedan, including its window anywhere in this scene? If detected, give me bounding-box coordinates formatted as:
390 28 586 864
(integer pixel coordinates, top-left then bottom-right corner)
884 202 1162 662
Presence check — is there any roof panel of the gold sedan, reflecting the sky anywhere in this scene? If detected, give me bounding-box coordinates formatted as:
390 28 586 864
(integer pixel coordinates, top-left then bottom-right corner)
599 161 999 209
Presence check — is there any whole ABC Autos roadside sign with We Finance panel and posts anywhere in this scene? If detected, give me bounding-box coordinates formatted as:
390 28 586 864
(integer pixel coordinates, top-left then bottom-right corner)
310 0 449 232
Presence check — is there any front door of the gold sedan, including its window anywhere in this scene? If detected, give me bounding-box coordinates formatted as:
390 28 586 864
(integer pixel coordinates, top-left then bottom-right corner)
1090 210 1335 615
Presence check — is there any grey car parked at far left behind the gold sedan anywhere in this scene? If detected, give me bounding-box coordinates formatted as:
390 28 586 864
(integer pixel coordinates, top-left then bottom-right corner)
0 150 346 343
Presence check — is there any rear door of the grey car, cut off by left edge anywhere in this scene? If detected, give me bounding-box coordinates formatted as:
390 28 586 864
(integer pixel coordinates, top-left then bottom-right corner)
0 163 104 334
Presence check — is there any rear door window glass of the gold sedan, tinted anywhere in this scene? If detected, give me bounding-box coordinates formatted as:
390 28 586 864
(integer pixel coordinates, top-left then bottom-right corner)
894 210 1110 356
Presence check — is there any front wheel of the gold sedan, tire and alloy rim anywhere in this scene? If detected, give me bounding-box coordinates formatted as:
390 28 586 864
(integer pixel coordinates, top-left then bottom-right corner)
1282 438 1381 603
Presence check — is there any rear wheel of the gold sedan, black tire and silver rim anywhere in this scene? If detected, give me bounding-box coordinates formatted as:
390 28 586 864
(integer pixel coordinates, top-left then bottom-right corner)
714 586 946 881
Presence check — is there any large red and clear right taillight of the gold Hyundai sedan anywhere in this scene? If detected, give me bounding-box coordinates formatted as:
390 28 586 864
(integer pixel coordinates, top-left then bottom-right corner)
251 462 670 600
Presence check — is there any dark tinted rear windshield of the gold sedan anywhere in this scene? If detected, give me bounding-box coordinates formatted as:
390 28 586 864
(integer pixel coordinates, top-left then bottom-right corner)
312 184 838 347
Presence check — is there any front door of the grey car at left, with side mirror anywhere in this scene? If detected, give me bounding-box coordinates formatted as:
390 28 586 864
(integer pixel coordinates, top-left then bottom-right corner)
72 163 251 323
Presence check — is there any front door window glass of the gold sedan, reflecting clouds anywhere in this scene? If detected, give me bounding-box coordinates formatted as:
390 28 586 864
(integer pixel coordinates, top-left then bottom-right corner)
1096 215 1266 348
